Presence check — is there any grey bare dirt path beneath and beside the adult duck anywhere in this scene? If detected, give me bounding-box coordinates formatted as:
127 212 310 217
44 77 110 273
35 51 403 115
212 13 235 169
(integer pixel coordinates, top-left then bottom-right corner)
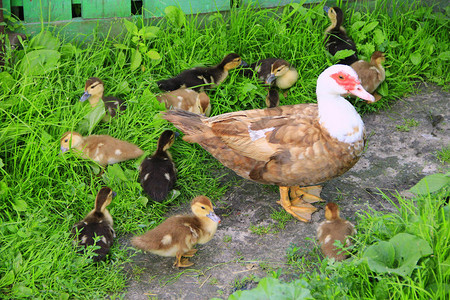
120 85 450 299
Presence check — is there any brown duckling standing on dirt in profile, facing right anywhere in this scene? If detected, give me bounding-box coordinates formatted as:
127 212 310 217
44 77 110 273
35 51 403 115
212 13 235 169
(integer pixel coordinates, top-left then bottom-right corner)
131 196 220 268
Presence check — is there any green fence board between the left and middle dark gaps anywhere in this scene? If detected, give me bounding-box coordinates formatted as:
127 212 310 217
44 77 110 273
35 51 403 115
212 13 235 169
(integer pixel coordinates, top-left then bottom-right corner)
23 0 72 23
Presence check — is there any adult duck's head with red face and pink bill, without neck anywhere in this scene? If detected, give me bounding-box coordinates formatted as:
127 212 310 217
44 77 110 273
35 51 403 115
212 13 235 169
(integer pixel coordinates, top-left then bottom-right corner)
316 65 375 102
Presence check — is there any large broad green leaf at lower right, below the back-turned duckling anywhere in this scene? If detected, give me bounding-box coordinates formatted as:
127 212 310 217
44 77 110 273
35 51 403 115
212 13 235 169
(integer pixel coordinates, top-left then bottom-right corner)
363 233 433 277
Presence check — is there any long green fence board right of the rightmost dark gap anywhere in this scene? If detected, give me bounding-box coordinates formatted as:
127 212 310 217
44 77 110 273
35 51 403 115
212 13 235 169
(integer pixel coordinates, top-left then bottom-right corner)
143 0 230 18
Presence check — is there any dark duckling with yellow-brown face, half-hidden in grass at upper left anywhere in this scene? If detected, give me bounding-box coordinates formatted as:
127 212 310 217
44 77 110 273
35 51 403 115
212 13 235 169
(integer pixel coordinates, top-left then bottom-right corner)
80 77 126 122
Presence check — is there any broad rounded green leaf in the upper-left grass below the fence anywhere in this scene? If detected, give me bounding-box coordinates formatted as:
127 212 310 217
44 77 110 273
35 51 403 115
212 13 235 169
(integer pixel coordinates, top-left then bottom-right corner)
19 49 61 75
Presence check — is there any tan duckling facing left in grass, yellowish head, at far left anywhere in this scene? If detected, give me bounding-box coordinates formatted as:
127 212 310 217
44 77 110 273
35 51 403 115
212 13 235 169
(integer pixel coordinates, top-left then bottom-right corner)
61 131 144 167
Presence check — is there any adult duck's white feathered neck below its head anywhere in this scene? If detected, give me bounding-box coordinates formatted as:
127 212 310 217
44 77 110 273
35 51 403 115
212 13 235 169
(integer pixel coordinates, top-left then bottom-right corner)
317 92 364 143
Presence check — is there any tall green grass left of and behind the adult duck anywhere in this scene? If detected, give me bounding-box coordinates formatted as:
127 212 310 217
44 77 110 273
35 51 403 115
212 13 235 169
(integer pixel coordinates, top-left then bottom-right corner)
0 1 450 299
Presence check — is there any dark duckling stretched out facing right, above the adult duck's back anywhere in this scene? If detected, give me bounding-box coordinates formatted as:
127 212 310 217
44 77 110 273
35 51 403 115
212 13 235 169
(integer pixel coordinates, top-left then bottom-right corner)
157 53 247 91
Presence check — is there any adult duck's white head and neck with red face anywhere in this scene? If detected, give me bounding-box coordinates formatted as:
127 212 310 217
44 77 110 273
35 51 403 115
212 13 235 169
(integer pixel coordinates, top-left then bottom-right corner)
316 65 375 143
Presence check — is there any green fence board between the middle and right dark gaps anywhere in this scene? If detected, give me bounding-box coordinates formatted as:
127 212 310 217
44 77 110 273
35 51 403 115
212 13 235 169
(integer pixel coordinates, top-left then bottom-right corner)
81 0 131 19
